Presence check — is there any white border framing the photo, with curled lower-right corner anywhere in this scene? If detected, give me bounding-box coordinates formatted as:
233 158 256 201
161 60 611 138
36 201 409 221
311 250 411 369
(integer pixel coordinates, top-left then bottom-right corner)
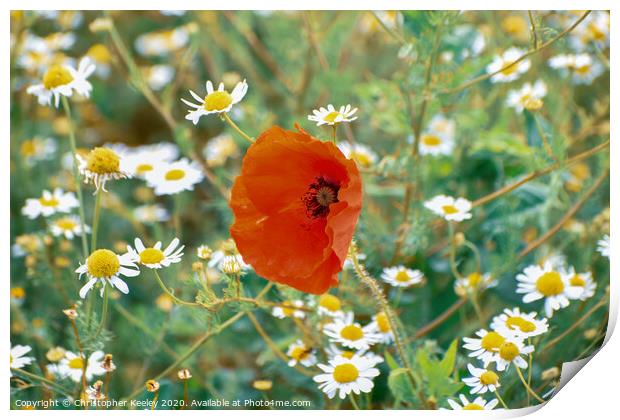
0 0 620 420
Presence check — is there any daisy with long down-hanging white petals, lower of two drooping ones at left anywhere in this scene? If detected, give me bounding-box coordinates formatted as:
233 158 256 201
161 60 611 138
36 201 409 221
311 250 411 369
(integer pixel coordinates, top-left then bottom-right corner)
75 249 140 299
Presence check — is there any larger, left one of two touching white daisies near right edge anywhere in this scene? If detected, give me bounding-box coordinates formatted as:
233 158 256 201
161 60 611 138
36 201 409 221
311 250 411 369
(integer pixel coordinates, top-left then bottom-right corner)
517 262 582 317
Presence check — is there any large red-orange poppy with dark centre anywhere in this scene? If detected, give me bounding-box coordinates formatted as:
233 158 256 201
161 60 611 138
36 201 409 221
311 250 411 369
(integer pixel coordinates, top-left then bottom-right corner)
230 126 362 294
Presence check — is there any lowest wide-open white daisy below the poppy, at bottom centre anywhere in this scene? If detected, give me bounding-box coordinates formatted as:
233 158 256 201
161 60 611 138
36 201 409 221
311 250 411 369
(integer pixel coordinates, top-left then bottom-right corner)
313 356 380 399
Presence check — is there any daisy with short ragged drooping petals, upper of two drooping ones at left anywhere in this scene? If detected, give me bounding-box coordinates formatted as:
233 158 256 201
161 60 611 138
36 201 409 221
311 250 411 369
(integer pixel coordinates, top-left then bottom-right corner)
75 147 131 191
